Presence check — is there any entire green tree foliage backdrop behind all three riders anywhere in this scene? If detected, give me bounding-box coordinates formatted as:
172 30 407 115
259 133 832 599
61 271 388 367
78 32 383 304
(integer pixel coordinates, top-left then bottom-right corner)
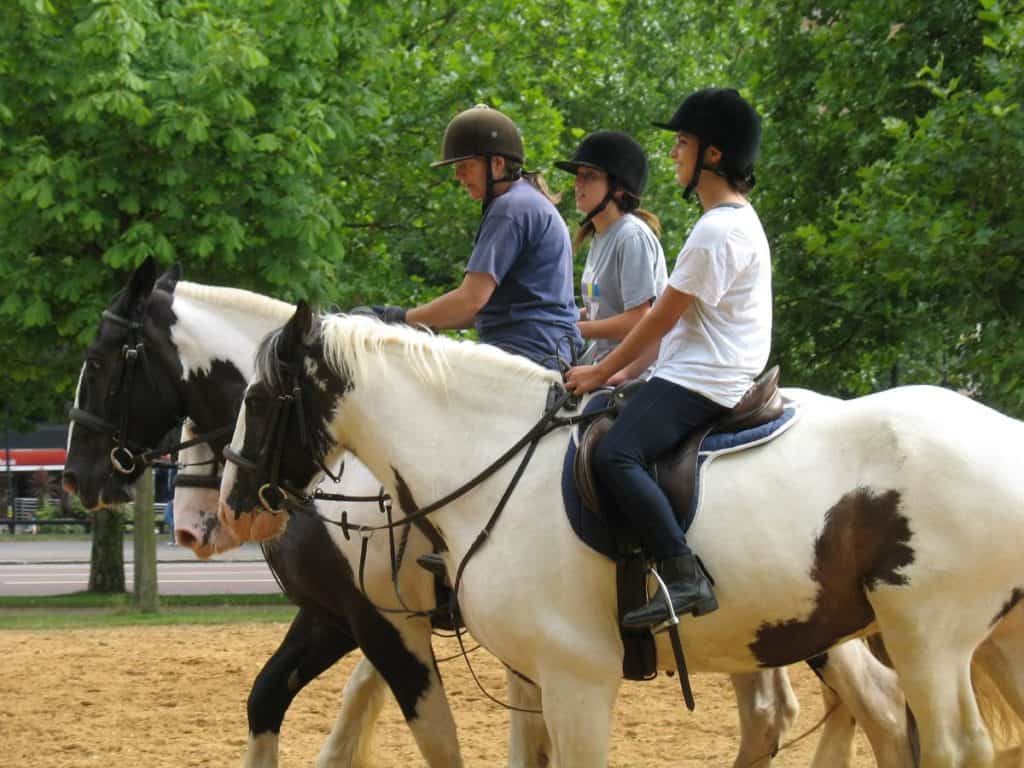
0 0 1024 428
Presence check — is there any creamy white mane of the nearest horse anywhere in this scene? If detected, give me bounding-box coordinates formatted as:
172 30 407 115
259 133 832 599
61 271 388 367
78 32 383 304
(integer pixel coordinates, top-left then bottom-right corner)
322 314 561 391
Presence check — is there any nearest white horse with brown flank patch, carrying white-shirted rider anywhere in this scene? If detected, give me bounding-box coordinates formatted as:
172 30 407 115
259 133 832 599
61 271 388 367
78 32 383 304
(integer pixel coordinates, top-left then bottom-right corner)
220 303 1024 768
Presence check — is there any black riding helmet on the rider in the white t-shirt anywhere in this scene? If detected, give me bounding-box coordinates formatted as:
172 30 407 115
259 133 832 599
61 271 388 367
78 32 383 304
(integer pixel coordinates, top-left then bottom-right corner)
654 88 761 198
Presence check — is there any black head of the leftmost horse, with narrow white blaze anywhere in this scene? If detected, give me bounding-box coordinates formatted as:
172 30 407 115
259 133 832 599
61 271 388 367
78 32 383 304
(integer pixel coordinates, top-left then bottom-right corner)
63 259 188 510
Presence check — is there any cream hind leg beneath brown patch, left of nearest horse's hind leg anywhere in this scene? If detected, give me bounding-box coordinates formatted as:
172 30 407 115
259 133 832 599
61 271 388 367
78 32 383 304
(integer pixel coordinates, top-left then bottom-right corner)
813 640 914 768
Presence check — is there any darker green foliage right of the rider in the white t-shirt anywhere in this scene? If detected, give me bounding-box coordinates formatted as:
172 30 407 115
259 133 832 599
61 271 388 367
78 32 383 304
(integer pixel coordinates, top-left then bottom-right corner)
752 0 1024 415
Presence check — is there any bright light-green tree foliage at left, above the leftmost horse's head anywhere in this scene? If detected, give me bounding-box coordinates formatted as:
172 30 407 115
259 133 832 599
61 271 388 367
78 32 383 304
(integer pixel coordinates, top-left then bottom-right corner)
0 0 376 421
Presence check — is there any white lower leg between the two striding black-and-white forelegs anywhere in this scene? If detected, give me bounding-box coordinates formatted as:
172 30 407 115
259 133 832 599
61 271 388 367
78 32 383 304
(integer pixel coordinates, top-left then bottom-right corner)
316 658 387 768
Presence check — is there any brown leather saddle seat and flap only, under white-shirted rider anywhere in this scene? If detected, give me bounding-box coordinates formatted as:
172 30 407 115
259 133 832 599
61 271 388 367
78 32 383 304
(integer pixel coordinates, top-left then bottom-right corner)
572 366 783 530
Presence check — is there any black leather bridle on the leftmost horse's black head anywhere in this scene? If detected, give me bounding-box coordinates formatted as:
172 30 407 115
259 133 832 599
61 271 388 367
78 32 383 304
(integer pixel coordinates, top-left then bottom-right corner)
68 309 233 475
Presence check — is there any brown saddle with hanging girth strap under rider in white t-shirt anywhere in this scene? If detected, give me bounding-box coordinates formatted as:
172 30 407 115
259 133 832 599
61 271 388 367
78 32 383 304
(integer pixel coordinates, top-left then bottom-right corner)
565 366 783 679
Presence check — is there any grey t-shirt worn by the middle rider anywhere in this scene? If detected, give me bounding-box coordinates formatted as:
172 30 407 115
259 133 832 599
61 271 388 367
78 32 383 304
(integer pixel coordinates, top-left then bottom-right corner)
581 213 669 362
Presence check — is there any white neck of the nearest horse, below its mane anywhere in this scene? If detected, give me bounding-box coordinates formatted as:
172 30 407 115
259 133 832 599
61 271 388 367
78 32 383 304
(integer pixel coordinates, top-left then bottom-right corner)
333 352 550 528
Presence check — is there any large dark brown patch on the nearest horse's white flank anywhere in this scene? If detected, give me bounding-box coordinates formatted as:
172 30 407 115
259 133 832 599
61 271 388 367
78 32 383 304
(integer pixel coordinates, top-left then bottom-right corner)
750 487 914 667
